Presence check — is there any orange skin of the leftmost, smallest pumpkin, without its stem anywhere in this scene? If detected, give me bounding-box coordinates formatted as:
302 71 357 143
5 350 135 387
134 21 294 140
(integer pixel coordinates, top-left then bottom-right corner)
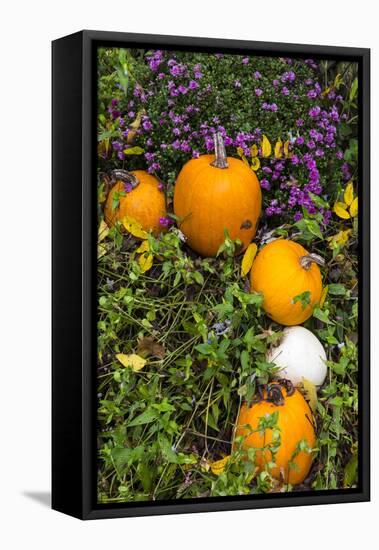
104 170 166 235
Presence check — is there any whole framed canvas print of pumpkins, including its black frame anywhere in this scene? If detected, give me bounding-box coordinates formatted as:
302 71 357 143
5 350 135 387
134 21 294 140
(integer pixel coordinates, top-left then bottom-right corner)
52 31 370 519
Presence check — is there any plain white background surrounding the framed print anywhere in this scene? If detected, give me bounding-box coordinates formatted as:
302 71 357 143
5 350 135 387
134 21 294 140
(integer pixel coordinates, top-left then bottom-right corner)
0 0 379 550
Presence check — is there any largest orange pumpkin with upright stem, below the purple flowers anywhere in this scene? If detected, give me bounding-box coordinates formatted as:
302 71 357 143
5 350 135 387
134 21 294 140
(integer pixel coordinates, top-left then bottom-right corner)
174 134 262 256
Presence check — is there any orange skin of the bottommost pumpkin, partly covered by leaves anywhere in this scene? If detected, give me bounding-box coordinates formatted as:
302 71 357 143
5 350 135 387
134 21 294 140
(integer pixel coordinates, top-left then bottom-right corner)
236 388 316 485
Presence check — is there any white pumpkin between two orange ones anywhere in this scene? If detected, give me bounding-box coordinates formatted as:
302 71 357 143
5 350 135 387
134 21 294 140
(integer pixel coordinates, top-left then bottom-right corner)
266 326 327 386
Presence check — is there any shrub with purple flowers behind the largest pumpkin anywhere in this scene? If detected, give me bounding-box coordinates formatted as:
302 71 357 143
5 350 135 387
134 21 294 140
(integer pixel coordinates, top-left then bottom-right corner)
100 50 360 227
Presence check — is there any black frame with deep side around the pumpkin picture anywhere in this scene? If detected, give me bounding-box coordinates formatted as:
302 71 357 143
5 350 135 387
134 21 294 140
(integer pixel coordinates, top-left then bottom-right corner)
52 30 370 519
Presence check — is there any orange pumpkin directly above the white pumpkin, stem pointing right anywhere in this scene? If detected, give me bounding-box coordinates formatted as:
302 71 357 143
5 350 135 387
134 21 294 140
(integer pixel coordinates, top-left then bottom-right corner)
250 239 324 325
